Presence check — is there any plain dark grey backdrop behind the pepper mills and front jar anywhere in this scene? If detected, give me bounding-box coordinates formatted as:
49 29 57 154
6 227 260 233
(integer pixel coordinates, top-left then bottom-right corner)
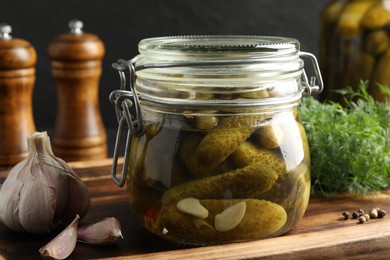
0 0 328 130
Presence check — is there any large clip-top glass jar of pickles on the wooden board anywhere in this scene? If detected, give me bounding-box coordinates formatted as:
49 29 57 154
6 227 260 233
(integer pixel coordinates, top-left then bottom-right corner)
110 36 322 245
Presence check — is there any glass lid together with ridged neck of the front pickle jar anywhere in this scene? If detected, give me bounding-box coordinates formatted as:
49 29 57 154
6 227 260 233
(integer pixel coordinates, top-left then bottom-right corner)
134 35 304 107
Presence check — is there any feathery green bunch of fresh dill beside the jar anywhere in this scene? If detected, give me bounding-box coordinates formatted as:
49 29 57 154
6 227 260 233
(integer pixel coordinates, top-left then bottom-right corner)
299 82 390 196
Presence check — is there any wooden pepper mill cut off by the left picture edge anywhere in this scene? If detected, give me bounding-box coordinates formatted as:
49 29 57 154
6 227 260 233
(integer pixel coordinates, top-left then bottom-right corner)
0 24 37 167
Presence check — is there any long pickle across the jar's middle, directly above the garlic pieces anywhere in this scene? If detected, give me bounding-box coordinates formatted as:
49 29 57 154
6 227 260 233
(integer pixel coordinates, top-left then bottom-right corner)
161 163 279 205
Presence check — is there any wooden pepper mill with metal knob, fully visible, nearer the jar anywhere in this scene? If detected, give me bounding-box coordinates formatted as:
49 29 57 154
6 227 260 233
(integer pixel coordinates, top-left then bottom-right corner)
48 20 107 161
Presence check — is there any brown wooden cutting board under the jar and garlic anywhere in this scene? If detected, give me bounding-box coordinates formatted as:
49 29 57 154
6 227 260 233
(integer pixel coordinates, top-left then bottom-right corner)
0 159 390 260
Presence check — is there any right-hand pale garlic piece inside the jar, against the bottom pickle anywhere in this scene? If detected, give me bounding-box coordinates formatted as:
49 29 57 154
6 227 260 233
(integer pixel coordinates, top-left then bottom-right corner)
214 201 246 232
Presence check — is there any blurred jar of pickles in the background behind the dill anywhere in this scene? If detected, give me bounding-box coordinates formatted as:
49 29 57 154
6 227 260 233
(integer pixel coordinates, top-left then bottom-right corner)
320 0 390 102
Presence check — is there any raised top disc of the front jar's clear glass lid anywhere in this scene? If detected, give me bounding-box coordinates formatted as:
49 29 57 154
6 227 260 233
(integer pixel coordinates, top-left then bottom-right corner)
138 35 300 61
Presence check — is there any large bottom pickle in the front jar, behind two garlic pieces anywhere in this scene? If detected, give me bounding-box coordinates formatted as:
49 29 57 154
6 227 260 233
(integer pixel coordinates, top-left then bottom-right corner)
157 199 287 244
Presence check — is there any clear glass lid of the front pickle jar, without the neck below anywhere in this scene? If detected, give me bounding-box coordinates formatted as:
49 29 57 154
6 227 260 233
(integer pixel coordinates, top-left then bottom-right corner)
134 35 304 84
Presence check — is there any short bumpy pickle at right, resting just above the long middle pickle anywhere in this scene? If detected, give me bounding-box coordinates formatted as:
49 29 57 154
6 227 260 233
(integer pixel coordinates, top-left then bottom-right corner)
232 141 286 175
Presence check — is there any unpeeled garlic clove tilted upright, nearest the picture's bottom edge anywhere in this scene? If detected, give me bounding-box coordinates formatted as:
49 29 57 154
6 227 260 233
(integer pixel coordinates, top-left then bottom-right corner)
39 215 80 259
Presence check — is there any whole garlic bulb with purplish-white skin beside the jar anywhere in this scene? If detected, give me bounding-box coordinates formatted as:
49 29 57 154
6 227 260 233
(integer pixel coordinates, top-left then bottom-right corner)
0 132 90 234
